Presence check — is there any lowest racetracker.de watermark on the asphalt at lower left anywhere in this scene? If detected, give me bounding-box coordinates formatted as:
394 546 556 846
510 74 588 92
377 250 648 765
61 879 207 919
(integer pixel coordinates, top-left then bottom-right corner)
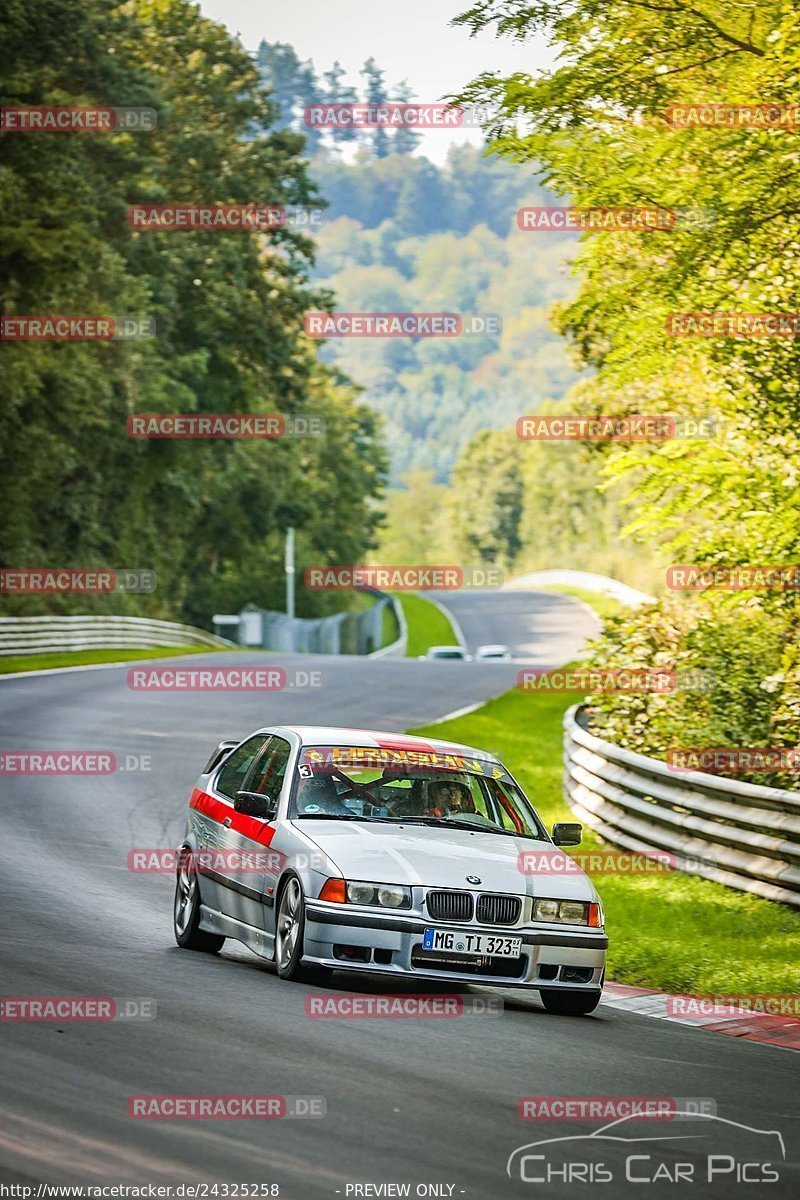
128 1094 327 1118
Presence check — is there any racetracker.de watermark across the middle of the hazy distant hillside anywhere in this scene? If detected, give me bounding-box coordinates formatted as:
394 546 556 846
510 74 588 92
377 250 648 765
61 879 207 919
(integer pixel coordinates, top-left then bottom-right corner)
303 312 503 338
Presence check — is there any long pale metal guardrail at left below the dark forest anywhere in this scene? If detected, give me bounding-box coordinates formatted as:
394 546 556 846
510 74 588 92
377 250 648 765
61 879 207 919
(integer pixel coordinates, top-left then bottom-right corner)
0 617 233 656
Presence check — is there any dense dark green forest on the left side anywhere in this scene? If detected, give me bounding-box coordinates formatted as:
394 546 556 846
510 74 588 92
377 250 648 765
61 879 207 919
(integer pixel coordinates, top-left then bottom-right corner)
0 7 386 624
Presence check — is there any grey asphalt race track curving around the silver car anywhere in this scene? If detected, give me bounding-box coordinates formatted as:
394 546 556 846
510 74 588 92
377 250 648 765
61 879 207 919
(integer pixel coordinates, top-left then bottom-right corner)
0 593 800 1200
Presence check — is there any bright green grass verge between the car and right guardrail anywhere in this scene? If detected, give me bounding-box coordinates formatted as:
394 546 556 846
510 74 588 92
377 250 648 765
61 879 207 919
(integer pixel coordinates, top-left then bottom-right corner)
410 691 800 994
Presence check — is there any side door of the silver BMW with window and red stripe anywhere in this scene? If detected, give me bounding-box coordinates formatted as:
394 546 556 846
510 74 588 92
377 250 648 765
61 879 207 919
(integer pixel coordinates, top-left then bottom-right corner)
200 736 291 930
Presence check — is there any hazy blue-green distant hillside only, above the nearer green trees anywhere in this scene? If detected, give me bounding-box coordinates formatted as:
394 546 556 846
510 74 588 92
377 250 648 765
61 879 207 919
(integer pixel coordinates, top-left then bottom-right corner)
257 42 577 482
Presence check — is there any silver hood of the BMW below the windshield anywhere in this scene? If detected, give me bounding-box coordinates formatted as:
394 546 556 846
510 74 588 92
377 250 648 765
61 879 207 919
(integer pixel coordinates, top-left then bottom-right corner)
291 817 597 900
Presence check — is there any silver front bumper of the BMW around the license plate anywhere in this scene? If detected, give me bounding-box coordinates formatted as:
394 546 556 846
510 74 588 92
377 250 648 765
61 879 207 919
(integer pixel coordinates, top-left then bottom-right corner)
303 900 608 991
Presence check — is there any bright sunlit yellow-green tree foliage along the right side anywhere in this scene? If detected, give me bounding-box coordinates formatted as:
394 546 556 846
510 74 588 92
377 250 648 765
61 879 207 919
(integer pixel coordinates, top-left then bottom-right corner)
458 0 800 782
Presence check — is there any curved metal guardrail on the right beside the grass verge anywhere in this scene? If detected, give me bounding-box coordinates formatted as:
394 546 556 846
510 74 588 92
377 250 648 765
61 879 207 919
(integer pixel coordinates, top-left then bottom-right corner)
564 704 800 907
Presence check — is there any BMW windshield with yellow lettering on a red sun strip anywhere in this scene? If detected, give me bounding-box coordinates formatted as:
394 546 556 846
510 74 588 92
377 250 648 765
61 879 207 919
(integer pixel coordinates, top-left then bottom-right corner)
289 746 549 841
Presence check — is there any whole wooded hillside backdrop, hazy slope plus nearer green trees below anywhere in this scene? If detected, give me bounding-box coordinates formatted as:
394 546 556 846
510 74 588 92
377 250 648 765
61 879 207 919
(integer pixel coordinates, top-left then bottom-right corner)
257 42 656 588
